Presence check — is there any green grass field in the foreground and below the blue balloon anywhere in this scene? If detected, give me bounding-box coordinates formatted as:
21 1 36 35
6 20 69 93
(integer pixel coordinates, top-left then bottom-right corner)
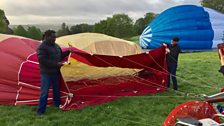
0 51 224 126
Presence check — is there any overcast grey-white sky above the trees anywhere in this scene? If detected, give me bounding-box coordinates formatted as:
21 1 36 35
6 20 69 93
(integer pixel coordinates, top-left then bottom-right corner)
0 0 200 25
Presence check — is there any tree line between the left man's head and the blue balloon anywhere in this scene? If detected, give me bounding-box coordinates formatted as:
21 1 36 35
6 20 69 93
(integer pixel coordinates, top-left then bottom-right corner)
57 12 157 38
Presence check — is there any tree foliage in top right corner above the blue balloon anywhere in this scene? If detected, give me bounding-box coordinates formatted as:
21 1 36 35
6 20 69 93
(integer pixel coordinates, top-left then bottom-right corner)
201 0 224 13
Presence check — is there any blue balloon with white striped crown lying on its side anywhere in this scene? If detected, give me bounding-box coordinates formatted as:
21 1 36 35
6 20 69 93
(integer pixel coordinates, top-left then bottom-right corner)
139 5 224 50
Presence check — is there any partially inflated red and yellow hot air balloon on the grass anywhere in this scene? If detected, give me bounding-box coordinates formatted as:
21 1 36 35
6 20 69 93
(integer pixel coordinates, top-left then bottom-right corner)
0 34 167 110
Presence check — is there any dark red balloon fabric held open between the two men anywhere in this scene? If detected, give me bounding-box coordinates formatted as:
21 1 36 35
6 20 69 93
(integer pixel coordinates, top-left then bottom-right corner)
59 47 167 110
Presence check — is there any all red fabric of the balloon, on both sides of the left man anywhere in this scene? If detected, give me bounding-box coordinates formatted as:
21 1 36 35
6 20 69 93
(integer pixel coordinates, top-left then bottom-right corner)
0 38 168 110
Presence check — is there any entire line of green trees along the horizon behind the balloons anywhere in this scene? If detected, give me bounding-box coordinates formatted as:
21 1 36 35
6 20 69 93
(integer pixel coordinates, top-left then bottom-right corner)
0 0 224 40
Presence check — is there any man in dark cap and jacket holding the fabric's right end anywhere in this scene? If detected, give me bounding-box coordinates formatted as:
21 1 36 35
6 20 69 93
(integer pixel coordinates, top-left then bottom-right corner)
165 37 181 91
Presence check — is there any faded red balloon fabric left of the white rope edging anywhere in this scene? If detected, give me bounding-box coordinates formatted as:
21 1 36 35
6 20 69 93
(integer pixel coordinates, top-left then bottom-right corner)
0 37 40 104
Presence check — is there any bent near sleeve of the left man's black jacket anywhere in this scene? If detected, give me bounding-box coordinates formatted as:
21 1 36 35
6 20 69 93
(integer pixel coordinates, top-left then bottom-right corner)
37 47 60 68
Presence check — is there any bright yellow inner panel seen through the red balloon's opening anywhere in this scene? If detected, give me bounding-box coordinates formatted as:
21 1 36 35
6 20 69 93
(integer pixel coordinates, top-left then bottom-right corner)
61 58 140 81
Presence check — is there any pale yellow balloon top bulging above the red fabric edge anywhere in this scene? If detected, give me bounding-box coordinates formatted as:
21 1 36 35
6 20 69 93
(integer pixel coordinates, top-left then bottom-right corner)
56 33 143 56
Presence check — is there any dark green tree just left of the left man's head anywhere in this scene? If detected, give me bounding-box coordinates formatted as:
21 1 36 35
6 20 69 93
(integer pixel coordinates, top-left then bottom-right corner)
27 26 42 40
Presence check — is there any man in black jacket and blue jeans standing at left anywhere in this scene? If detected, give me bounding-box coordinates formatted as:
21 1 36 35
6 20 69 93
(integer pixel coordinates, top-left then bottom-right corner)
37 30 70 115
